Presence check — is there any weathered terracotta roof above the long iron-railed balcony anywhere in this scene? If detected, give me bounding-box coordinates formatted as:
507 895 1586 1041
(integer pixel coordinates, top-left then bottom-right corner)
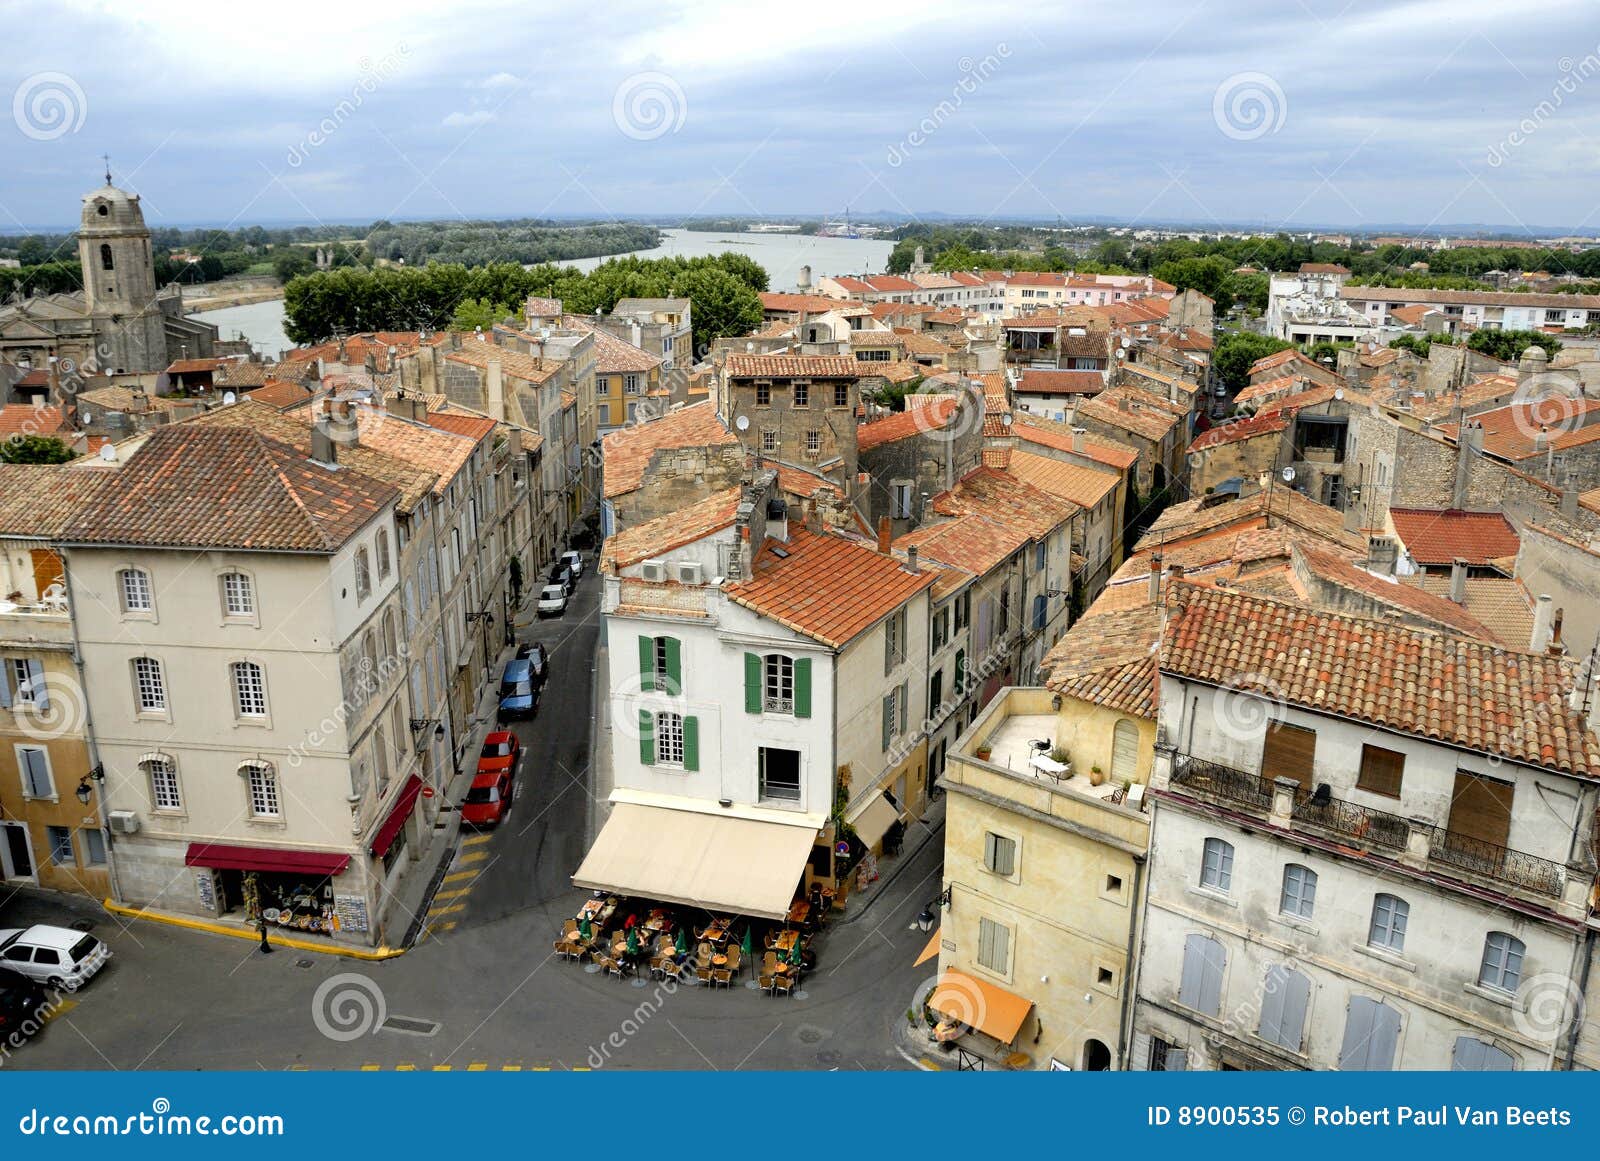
1160 584 1600 777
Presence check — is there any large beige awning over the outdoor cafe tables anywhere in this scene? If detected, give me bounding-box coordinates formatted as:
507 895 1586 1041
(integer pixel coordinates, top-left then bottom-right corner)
573 803 816 920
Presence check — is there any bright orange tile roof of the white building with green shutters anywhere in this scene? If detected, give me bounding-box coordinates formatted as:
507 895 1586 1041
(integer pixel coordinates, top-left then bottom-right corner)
723 525 936 649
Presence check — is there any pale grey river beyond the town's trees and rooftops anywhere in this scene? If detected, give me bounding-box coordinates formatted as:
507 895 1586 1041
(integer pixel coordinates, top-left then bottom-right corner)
195 230 894 358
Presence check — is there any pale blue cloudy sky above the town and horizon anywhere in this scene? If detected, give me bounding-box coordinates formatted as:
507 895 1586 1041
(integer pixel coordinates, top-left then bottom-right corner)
0 0 1600 233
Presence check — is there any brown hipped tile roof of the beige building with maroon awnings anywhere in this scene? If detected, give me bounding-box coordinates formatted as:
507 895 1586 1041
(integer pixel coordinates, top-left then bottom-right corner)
61 424 397 553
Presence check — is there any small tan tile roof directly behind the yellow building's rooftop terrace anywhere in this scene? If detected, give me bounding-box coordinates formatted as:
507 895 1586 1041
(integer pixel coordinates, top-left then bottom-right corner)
1040 604 1162 718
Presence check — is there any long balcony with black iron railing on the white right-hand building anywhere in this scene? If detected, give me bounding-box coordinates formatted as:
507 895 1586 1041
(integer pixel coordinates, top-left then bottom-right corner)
1171 756 1566 899
